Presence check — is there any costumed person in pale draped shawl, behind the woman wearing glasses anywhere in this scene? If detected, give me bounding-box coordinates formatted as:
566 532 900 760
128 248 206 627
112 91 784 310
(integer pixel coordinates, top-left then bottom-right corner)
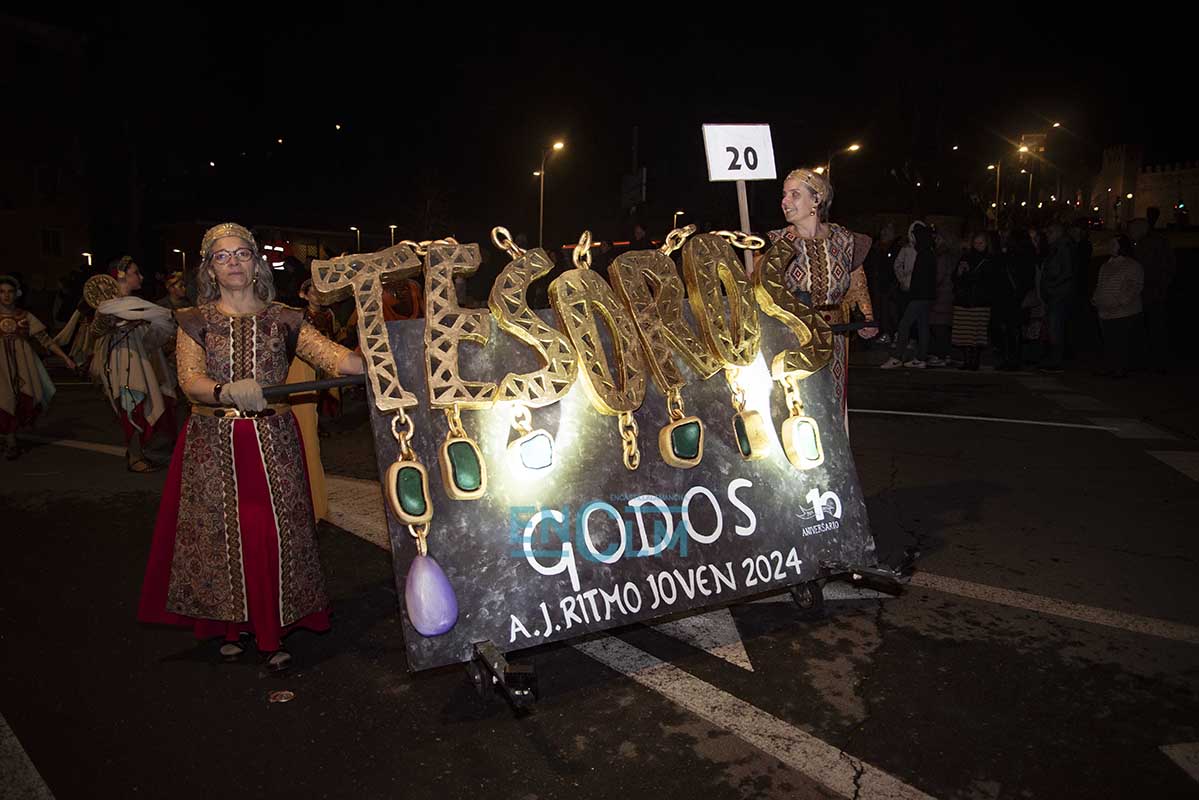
91 255 175 473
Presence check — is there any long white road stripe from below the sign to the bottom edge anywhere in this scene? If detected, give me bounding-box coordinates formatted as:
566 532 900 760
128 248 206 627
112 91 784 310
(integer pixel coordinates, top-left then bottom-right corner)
574 636 929 800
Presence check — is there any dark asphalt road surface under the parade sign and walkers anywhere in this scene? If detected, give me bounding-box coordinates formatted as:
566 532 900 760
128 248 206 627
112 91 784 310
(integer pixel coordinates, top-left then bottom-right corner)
0 357 1199 800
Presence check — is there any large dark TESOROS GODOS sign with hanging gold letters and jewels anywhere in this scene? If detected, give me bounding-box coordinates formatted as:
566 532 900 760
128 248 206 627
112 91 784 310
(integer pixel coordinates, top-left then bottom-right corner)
313 225 874 669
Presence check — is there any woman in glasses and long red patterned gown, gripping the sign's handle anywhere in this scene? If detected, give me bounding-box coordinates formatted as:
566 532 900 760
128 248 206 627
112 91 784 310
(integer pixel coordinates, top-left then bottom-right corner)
138 222 364 672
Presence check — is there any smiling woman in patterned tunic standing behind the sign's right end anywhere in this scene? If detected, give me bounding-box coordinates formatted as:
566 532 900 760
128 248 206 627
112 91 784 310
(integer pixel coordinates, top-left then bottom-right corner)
766 169 878 431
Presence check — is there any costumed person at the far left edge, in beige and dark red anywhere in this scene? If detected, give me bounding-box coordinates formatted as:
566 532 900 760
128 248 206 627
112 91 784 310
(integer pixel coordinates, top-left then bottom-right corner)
0 275 76 459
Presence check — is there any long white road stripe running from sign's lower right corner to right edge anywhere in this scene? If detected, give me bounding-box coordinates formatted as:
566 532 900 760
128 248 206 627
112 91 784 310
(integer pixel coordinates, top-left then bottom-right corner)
911 572 1199 644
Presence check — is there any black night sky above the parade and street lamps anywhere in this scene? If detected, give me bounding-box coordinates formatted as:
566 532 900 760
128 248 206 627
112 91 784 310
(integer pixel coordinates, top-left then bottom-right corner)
19 4 1199 250
